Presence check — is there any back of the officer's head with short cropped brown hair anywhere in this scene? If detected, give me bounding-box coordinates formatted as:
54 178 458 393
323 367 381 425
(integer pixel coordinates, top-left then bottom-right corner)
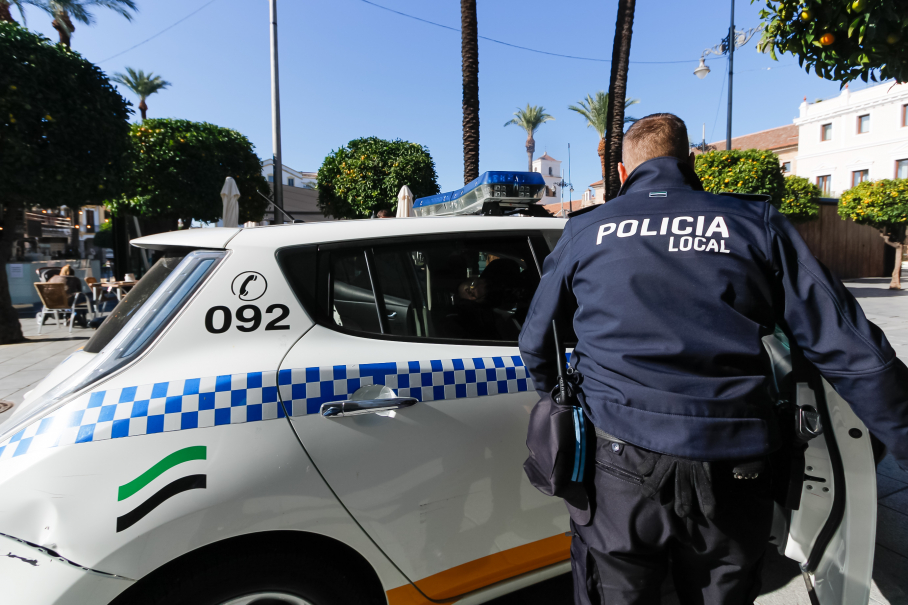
621 113 690 172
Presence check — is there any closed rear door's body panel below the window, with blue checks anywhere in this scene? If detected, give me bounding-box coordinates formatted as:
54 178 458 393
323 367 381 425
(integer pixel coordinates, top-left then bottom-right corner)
281 326 569 598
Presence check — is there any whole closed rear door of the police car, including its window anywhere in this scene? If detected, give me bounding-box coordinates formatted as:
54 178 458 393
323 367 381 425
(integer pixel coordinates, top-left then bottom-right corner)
278 232 570 599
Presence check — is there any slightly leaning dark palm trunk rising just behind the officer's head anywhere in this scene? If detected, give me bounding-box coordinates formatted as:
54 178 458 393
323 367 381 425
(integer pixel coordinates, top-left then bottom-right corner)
602 0 636 201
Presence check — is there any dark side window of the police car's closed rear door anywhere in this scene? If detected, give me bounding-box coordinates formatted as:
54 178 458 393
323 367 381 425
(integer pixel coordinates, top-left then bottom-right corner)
278 232 549 343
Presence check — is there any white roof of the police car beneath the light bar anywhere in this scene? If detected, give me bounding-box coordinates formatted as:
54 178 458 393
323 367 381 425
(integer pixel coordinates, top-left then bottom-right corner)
130 215 566 250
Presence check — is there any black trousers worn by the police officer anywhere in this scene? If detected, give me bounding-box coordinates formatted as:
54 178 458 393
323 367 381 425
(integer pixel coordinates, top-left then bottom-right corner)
571 439 773 605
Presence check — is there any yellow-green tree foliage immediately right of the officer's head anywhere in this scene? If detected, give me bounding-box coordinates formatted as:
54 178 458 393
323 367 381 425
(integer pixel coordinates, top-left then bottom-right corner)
695 149 785 210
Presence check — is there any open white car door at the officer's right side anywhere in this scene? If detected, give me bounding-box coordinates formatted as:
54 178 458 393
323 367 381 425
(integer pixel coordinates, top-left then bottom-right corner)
764 331 877 605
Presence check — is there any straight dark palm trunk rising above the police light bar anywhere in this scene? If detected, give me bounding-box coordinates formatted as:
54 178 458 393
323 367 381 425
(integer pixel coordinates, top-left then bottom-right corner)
460 0 479 185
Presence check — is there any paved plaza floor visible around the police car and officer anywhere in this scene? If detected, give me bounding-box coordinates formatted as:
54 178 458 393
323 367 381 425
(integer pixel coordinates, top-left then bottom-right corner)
0 279 908 605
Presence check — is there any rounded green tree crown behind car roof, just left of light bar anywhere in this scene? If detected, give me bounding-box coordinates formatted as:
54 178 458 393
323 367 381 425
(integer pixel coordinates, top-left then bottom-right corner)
317 137 438 219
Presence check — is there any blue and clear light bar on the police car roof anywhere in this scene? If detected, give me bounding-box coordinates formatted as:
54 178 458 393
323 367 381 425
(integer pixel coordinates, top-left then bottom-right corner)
413 171 545 216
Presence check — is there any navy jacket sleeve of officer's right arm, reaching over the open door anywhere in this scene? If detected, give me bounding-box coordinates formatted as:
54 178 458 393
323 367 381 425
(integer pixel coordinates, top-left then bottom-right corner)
767 206 908 468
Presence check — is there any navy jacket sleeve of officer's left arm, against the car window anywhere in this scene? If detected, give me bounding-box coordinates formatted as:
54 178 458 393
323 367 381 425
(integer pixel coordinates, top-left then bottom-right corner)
519 221 577 393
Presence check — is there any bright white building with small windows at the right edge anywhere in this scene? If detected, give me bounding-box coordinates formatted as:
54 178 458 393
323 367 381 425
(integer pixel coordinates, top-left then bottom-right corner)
794 82 908 197
